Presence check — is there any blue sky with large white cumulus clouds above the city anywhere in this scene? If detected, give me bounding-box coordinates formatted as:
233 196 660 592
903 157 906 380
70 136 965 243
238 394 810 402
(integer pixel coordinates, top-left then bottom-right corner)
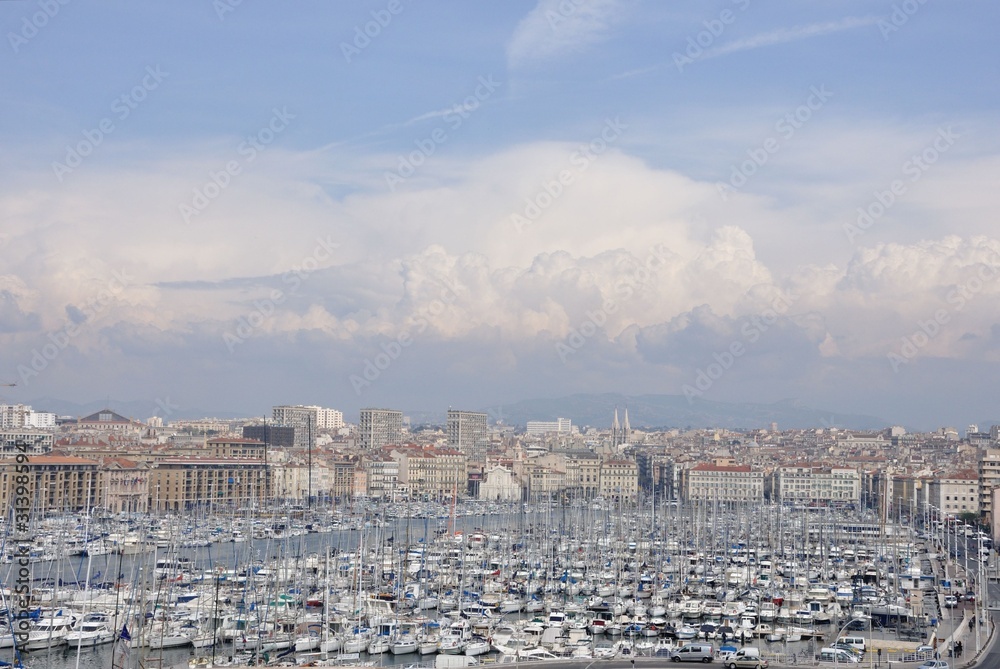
0 0 1000 427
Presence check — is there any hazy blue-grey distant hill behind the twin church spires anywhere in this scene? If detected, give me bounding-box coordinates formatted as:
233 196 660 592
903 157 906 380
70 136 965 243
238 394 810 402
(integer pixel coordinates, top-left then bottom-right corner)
470 393 888 430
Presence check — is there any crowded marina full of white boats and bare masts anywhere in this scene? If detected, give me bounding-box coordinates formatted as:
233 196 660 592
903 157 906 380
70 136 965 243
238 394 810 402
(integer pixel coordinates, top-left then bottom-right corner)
0 500 989 669
